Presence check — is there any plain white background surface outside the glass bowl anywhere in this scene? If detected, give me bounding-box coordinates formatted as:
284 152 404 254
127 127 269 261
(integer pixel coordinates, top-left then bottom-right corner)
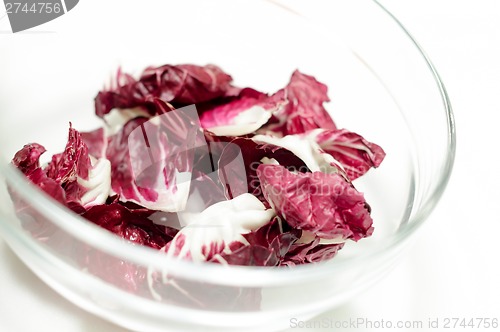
0 0 500 332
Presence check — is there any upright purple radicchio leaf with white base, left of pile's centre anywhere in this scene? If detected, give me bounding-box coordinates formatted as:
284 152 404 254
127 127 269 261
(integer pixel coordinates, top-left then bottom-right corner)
107 99 200 212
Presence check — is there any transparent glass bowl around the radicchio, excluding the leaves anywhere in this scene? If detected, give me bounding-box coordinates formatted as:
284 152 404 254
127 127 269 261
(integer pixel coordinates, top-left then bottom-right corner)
0 0 455 331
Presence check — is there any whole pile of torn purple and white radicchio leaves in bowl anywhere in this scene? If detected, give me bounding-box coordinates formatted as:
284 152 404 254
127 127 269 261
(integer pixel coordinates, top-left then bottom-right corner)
12 64 385 266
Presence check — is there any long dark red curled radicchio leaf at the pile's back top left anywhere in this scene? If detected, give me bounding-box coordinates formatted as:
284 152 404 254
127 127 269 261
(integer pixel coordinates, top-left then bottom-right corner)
95 64 239 117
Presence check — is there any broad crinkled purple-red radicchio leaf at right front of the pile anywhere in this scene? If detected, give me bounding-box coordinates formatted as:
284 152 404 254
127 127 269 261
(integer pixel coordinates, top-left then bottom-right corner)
257 165 373 241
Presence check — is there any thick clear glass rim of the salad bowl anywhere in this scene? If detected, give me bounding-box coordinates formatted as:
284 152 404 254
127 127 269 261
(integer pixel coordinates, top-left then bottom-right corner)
0 0 456 287
